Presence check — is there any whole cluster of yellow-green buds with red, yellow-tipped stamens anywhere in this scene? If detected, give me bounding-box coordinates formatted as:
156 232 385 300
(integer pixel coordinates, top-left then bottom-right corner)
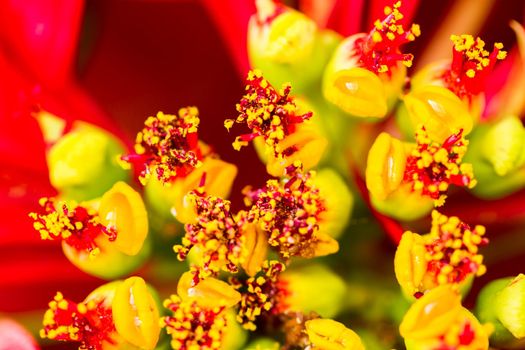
30 0 525 350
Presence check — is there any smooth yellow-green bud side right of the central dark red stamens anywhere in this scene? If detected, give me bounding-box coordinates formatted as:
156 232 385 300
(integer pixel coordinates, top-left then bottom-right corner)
313 168 354 238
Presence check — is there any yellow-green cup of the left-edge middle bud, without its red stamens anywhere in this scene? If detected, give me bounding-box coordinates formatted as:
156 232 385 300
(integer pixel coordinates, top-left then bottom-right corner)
62 182 151 279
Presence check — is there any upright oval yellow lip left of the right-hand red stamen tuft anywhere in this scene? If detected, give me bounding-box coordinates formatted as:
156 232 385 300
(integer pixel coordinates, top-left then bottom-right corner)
365 132 408 200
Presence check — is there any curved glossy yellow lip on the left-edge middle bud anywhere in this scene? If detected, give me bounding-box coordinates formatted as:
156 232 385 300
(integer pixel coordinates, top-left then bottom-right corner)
99 182 148 255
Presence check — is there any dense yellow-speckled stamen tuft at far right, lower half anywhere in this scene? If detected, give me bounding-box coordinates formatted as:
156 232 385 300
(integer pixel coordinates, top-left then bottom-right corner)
423 210 488 285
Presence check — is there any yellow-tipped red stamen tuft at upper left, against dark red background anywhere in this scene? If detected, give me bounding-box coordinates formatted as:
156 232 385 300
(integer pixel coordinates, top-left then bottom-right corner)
122 107 203 184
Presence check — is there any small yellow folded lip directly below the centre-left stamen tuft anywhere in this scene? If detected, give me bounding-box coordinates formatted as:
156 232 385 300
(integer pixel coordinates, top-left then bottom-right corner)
177 272 241 308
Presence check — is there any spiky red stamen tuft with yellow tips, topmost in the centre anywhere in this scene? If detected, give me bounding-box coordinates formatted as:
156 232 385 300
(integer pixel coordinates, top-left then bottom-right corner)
224 70 312 158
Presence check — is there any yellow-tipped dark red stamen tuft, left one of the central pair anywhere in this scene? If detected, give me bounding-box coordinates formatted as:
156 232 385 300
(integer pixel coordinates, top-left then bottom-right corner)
173 191 247 284
